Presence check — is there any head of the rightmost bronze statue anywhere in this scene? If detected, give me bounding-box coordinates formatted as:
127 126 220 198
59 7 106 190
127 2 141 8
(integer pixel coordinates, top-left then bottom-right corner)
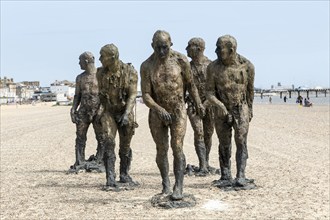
215 35 237 65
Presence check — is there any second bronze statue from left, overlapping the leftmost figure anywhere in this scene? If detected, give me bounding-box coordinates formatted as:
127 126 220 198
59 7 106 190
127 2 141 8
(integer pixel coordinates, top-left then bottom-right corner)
97 44 138 188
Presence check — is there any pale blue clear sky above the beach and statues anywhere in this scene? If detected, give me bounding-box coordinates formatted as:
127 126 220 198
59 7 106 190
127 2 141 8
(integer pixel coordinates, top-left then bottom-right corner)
0 0 330 88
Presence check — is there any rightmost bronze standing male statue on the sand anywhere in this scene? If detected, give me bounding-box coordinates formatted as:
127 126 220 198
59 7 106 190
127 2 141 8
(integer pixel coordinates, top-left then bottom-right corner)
206 35 255 188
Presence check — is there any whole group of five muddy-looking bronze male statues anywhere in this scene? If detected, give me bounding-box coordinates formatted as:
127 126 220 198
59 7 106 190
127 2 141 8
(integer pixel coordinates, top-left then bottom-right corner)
71 31 254 205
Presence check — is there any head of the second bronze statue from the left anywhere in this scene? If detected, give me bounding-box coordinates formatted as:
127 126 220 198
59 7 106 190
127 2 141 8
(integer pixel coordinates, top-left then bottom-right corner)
99 44 119 67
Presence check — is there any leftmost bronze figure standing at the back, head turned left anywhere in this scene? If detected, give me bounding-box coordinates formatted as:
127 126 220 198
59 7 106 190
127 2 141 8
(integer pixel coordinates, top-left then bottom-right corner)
70 52 103 171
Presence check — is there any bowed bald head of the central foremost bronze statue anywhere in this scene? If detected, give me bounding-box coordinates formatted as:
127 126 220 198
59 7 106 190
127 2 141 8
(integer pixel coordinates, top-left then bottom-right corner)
151 30 173 60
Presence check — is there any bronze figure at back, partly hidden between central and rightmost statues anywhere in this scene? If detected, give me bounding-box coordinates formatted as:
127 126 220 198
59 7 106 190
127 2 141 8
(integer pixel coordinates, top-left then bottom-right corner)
186 38 215 176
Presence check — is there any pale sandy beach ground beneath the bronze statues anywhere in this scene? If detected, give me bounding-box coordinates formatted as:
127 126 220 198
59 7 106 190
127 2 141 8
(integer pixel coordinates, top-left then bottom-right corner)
0 103 330 219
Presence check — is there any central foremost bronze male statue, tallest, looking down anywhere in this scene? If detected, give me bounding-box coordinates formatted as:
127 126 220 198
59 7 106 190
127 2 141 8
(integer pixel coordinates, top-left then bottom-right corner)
140 31 205 200
